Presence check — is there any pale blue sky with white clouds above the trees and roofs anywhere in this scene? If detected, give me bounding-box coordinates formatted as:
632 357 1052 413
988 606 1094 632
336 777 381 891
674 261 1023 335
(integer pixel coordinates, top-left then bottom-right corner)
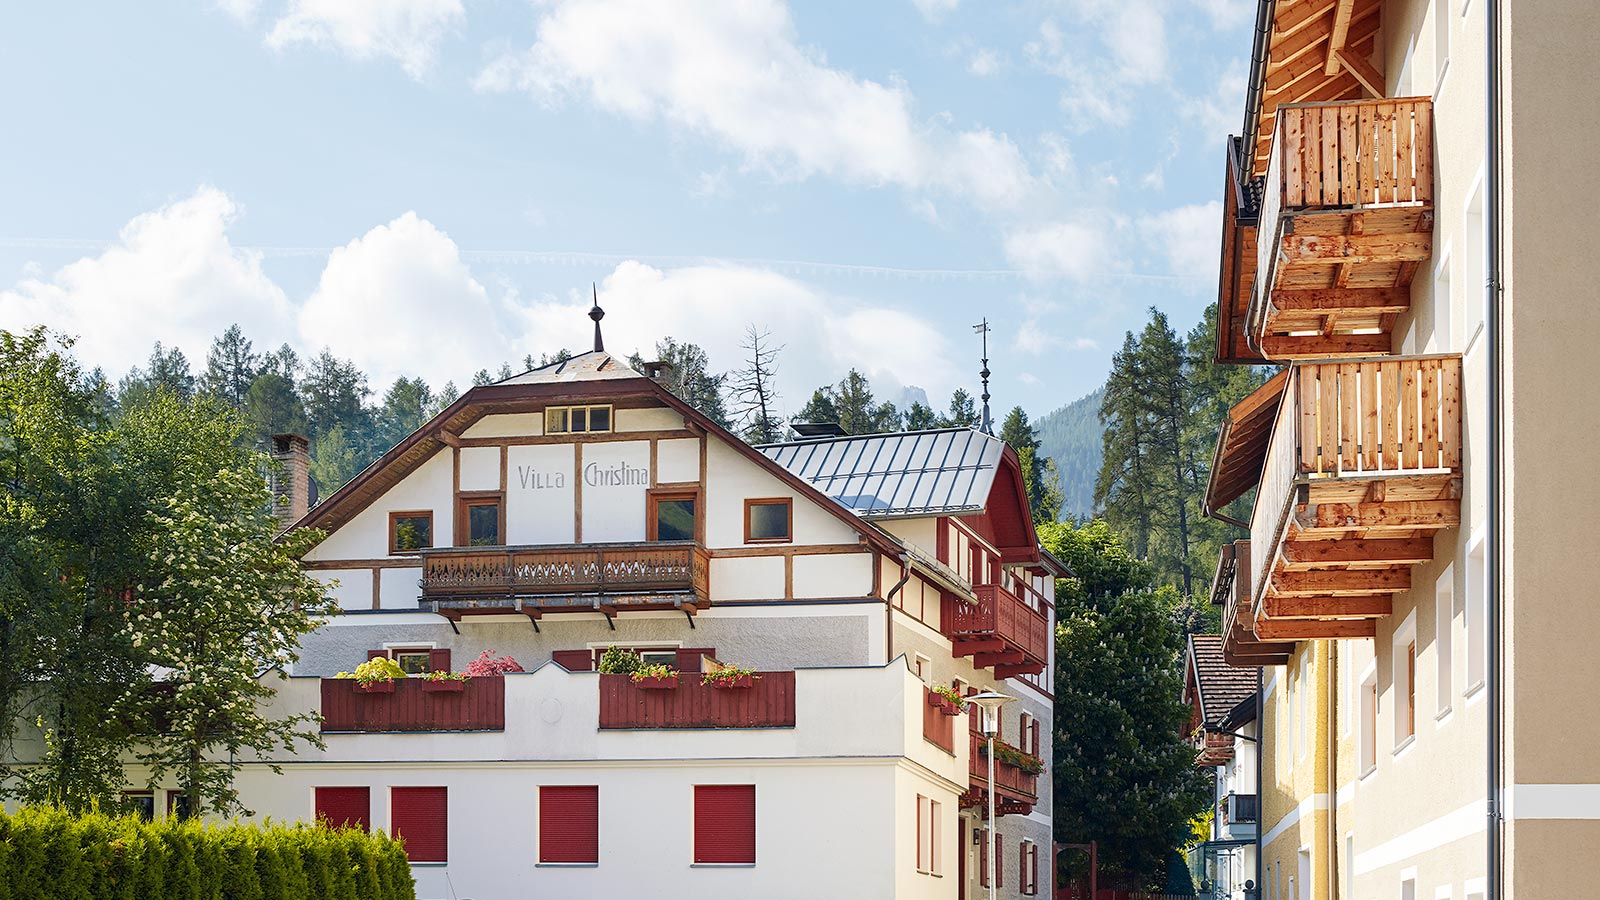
0 0 1253 415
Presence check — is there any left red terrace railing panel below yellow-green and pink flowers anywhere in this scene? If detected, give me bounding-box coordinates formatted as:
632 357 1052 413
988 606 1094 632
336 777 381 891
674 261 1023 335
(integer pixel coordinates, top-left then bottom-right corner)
322 677 506 733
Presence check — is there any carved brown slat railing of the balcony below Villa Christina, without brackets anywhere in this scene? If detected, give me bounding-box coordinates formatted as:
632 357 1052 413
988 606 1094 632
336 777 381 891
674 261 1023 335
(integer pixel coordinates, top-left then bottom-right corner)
421 541 710 597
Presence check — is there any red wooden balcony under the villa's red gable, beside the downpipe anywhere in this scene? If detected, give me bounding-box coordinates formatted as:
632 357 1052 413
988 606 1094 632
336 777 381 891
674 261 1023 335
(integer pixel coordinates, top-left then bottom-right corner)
941 585 1051 677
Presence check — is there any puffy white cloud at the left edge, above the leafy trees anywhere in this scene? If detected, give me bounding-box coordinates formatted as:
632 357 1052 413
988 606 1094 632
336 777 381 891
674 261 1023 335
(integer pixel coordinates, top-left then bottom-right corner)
0 187 291 380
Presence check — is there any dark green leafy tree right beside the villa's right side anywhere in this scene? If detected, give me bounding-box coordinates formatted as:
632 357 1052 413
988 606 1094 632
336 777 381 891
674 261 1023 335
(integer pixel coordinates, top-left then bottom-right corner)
1040 522 1210 886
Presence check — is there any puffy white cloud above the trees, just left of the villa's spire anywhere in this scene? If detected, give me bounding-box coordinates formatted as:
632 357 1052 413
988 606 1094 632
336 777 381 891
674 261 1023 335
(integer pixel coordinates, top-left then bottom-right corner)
299 213 528 391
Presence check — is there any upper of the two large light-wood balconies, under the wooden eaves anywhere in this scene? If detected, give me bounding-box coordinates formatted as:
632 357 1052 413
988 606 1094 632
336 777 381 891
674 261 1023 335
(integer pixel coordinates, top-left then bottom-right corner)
1246 98 1434 360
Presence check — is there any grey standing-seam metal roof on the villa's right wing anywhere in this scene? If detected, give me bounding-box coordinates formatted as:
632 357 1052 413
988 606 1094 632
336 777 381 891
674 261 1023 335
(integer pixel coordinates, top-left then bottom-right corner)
757 428 1005 519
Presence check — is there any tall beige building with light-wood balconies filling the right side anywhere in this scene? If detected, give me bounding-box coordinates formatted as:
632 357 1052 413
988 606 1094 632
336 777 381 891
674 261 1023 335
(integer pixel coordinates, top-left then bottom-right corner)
1206 0 1600 900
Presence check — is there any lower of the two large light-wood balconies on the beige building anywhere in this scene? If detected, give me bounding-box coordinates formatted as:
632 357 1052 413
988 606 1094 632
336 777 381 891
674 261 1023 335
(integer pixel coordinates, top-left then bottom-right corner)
1235 356 1461 640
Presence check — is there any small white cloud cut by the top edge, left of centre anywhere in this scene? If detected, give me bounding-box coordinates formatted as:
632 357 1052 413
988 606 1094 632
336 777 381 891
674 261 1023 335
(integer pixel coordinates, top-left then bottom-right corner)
262 0 466 78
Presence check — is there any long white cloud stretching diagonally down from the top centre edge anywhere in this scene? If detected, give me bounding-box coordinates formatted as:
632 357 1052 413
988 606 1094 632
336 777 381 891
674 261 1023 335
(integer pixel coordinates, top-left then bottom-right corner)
477 0 1032 207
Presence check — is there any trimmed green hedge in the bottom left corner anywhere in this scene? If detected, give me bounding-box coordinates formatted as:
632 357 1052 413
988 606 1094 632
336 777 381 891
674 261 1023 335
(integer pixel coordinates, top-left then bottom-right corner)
0 807 416 900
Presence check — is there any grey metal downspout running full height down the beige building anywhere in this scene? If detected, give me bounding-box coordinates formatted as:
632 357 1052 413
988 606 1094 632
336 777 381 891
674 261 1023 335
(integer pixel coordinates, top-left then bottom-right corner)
1483 0 1506 900
